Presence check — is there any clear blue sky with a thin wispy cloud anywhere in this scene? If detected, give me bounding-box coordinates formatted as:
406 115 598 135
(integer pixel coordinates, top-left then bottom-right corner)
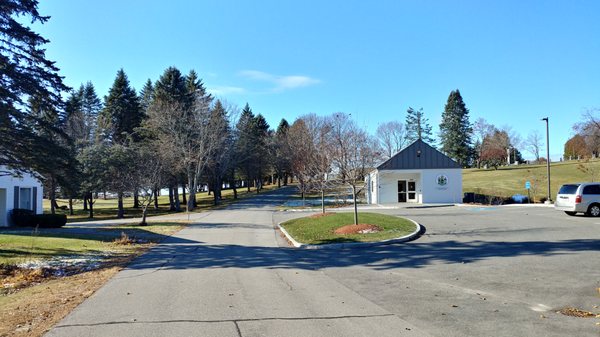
35 0 600 159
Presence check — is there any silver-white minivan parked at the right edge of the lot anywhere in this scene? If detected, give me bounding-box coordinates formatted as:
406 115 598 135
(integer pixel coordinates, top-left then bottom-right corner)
554 183 600 217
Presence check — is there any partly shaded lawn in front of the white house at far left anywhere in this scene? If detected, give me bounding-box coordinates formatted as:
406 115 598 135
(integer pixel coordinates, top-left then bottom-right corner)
0 222 184 264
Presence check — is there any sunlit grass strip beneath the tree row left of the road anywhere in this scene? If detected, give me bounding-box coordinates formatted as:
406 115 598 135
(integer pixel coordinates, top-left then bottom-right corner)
44 184 277 222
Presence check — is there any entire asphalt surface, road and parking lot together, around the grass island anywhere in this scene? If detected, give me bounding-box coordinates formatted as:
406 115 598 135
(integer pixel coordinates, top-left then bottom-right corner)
47 190 600 337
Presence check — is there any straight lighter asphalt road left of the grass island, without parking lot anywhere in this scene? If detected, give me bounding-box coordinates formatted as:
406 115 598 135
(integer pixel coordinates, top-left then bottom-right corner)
46 189 427 337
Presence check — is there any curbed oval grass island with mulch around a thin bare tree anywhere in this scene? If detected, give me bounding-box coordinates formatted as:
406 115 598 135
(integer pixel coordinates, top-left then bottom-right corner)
281 213 416 244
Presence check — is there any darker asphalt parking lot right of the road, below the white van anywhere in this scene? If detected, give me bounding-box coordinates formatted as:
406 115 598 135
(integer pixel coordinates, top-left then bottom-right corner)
276 206 600 337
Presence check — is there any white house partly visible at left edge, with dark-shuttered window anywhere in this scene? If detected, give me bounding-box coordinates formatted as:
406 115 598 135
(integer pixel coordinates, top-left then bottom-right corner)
0 167 43 227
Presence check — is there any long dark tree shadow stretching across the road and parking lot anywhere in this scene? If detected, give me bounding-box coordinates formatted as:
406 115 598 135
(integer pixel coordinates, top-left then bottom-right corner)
129 231 600 270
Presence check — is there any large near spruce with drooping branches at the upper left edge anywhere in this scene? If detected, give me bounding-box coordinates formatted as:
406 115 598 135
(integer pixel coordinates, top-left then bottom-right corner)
0 0 68 171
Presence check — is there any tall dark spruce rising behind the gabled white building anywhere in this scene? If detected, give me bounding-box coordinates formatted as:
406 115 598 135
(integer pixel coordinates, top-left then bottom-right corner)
440 89 473 166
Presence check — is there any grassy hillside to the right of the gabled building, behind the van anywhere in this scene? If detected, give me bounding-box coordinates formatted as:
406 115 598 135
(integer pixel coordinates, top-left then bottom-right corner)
463 160 600 201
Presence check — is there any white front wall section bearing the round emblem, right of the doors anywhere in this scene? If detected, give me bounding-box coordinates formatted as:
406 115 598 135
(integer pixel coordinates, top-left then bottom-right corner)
422 169 463 203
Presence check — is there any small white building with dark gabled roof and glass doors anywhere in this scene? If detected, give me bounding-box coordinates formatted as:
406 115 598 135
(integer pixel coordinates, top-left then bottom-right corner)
366 139 463 204
